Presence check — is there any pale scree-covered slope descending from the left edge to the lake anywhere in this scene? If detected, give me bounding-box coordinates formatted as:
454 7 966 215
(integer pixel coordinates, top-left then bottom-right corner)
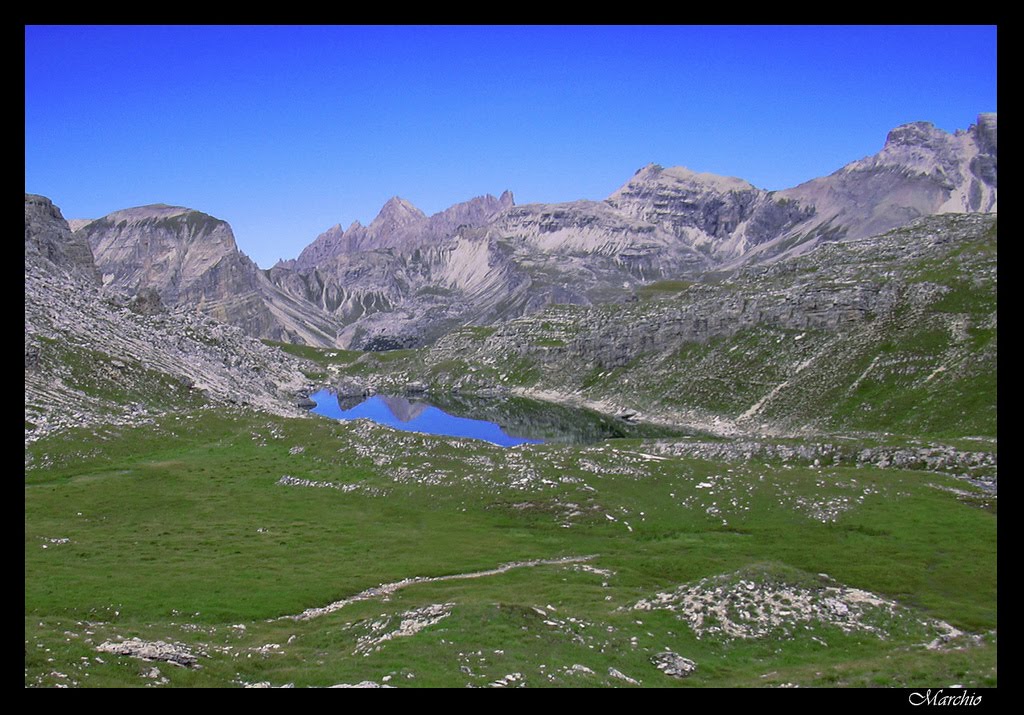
25 195 306 439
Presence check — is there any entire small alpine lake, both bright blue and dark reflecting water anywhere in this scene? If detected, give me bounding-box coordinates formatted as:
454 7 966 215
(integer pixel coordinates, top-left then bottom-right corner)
303 390 680 447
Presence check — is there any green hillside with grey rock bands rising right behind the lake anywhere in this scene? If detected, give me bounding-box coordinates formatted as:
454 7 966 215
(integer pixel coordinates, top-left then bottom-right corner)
356 208 997 440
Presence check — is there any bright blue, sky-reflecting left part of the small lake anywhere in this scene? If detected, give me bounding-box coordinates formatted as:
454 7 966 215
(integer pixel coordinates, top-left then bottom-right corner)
310 390 544 447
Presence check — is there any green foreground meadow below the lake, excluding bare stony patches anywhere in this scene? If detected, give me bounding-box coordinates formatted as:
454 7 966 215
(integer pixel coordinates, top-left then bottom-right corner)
25 411 996 687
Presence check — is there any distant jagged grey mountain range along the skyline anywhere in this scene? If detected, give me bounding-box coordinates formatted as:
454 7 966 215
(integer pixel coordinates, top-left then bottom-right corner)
64 114 997 350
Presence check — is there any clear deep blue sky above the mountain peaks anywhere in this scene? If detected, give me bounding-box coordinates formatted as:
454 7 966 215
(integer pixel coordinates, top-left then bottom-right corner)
25 26 996 267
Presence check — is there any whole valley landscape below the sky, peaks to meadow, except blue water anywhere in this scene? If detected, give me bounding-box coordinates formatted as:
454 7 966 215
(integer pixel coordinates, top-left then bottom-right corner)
25 115 998 688
